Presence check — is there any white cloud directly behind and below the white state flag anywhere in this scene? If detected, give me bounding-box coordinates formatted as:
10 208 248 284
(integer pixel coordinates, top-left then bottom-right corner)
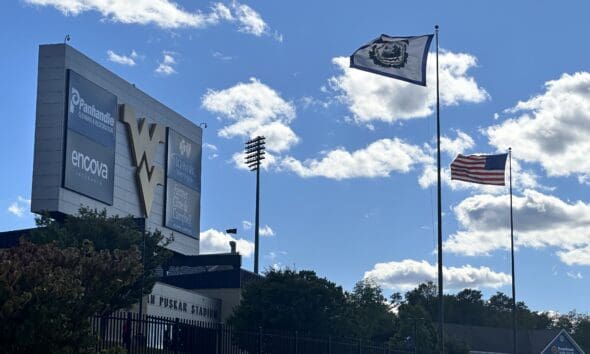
329 52 488 124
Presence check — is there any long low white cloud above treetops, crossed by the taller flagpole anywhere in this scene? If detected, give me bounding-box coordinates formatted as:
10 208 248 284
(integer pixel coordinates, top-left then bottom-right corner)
364 259 511 291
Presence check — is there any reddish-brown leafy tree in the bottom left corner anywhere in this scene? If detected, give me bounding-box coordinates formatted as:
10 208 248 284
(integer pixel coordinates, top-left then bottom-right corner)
0 241 141 353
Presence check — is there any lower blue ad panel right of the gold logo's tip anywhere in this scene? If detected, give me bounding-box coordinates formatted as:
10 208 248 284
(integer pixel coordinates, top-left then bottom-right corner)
164 178 200 238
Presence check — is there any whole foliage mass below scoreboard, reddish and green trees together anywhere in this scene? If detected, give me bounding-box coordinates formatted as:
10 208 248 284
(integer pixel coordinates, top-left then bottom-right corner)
0 209 169 353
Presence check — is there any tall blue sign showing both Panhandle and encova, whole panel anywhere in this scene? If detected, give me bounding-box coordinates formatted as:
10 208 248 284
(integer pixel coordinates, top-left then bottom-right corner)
63 70 117 205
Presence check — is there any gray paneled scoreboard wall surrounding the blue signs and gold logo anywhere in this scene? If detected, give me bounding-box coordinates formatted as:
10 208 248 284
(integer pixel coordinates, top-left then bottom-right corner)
31 44 202 255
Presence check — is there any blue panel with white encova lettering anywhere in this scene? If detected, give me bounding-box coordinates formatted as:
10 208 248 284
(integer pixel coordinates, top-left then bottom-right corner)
64 130 115 205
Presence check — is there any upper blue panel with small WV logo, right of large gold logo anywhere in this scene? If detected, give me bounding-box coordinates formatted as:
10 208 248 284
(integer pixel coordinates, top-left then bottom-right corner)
166 129 201 192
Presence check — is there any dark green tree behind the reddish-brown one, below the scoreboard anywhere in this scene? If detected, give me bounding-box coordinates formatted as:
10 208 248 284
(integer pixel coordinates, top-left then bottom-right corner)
31 208 172 315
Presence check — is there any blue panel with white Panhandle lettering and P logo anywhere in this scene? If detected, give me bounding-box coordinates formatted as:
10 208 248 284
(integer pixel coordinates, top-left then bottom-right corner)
67 70 118 147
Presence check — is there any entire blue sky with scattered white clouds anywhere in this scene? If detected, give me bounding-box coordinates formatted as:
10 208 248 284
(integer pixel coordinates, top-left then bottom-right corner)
0 0 590 313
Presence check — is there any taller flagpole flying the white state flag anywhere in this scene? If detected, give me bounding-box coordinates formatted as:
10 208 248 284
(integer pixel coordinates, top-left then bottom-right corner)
434 25 445 354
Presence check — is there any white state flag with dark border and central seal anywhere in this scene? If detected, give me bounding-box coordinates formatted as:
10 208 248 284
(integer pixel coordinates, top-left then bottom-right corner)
350 34 433 86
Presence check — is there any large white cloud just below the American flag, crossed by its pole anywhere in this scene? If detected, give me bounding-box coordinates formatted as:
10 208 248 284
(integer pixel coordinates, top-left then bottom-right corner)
444 189 590 265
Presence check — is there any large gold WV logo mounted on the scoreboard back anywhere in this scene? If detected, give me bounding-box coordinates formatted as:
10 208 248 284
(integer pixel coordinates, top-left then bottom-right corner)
120 104 164 217
